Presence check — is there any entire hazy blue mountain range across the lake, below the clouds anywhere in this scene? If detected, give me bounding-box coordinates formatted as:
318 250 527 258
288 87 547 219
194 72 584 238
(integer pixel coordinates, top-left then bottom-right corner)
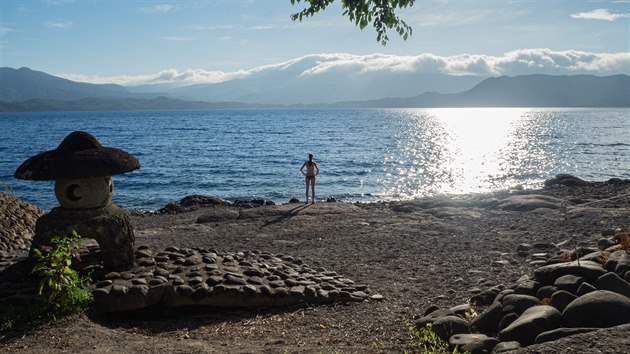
0 66 630 111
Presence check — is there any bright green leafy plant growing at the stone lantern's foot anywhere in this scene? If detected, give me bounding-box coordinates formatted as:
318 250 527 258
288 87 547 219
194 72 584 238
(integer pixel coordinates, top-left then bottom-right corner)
32 230 92 318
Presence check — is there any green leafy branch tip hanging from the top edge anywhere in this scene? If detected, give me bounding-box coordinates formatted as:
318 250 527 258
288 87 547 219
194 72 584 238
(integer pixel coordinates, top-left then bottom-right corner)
291 0 415 45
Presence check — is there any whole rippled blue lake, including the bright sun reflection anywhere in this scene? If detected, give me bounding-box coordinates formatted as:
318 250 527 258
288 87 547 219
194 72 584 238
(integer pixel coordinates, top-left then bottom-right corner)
0 108 630 209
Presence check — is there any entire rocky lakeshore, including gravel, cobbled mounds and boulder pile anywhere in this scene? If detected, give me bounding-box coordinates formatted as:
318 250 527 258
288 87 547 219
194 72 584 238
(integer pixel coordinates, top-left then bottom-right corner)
0 175 630 353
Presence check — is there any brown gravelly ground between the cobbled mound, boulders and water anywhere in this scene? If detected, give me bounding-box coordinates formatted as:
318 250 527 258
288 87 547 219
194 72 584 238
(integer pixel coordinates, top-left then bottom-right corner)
0 178 630 353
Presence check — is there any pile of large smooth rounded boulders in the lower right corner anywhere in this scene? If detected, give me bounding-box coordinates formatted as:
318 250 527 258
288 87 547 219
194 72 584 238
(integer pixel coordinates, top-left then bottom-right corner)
416 231 630 354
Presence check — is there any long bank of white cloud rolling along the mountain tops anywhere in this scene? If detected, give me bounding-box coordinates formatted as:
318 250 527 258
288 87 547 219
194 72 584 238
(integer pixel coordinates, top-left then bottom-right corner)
61 48 630 86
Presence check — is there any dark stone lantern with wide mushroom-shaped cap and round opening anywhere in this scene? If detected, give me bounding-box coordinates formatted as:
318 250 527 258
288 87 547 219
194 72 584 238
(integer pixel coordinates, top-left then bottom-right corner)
14 131 140 270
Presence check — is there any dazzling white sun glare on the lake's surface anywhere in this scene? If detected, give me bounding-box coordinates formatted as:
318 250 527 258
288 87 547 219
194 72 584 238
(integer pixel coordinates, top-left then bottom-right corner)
381 108 552 199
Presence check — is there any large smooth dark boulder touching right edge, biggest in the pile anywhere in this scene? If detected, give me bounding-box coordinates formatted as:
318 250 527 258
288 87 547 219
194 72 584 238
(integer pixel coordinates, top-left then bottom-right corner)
562 290 630 328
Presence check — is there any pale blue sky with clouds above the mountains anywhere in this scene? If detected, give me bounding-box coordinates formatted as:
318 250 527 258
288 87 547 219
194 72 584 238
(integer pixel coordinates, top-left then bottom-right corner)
0 0 630 85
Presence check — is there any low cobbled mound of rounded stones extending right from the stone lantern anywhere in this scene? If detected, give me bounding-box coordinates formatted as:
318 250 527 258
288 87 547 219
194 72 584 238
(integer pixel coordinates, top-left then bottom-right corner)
91 247 369 312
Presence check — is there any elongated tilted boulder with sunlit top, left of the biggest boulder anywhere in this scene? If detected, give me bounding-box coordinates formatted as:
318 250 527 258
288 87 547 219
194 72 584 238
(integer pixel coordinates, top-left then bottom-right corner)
499 305 562 346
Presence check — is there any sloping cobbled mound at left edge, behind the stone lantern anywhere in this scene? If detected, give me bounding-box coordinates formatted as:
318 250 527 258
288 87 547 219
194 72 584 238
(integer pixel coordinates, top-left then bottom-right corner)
0 192 44 256
